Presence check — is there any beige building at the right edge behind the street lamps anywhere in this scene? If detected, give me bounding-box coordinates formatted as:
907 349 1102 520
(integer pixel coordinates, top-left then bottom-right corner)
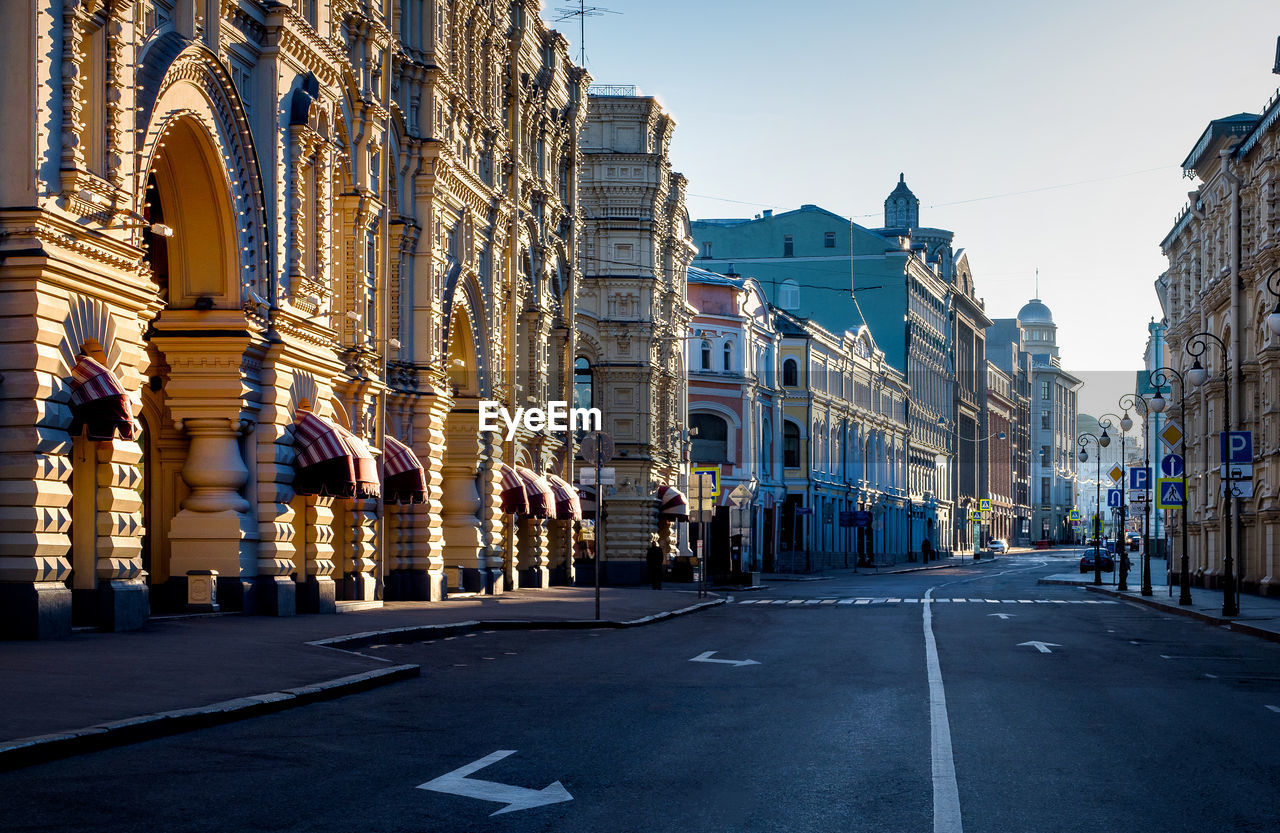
1152 63 1280 595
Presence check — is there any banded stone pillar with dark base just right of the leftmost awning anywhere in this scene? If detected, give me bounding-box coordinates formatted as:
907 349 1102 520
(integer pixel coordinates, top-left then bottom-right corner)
95 439 151 631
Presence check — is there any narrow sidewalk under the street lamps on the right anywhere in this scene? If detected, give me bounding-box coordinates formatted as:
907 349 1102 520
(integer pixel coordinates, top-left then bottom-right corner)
1039 558 1280 642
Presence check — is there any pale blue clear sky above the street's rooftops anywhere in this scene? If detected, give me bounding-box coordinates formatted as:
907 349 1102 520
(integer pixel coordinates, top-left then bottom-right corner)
543 0 1280 413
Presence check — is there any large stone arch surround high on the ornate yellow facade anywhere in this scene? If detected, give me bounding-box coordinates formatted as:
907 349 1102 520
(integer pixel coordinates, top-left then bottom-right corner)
133 38 273 307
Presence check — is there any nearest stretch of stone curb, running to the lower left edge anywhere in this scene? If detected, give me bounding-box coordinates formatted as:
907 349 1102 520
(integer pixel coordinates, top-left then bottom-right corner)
0 665 420 772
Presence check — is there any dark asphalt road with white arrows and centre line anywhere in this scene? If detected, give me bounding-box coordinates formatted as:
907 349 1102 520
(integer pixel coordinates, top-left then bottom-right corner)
0 555 1280 833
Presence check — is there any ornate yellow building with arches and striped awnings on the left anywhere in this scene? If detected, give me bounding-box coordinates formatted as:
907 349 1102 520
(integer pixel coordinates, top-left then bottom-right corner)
0 0 588 636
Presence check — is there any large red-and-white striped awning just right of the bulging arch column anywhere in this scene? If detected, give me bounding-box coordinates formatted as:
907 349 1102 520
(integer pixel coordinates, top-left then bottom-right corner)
293 411 381 498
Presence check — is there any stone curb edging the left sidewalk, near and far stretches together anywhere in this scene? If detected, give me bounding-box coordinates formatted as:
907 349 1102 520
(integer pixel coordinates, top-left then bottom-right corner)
0 599 727 772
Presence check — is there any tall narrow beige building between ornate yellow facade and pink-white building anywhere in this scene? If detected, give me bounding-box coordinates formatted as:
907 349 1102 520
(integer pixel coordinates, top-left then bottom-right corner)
573 86 695 583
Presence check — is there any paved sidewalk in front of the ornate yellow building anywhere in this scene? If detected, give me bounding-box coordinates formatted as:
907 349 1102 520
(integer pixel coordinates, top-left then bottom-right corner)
0 587 724 769
